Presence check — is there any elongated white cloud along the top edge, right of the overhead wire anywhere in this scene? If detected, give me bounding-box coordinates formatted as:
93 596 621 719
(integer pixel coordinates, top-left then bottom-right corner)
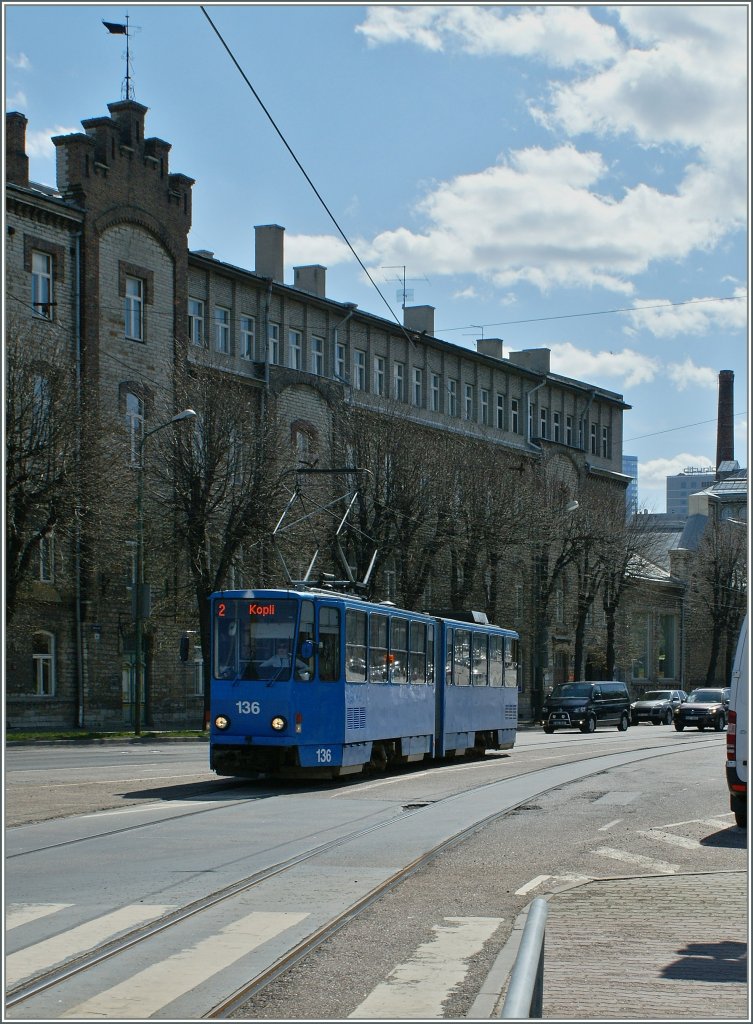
357 4 620 68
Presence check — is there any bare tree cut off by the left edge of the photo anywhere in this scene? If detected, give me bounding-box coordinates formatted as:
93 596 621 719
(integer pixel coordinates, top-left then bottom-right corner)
5 319 80 621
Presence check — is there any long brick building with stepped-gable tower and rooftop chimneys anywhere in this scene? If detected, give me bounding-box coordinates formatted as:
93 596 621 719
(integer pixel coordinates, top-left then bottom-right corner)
6 100 655 728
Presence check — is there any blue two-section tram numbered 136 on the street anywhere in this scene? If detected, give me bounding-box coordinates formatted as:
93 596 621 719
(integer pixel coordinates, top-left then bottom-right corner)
210 589 518 777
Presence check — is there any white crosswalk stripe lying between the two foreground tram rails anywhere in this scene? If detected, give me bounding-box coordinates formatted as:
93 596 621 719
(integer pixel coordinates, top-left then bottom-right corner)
60 911 308 1021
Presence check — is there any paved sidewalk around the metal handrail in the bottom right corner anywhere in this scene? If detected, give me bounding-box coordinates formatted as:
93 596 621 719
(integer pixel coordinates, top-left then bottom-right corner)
468 871 751 1021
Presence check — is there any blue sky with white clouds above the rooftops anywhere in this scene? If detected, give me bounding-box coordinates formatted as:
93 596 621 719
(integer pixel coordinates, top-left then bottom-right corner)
3 3 751 512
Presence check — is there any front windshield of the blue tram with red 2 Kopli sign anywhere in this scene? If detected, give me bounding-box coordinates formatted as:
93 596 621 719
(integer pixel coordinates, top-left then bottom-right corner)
213 598 308 680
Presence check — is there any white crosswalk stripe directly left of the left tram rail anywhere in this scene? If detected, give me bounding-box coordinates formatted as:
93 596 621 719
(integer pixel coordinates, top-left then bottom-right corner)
5 903 174 986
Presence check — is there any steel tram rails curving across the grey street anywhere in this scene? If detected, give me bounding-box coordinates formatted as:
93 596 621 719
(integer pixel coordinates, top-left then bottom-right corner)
6 742 717 1019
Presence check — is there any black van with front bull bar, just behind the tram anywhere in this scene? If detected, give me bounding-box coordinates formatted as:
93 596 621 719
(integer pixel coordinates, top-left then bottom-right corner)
541 680 630 732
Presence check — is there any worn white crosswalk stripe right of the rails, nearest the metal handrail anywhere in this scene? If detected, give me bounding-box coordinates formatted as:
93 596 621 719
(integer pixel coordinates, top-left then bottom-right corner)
348 918 503 1020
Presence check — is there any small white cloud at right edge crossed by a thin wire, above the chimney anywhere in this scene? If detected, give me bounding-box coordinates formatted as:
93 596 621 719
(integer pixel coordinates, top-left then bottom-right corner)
625 288 748 338
